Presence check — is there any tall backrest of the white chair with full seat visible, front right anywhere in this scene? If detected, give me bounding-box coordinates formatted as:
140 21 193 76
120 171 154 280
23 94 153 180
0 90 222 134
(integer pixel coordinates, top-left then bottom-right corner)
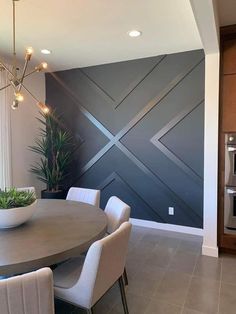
73 222 131 308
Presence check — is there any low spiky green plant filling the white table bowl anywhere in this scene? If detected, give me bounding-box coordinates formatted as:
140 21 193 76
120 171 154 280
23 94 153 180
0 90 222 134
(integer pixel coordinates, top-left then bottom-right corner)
0 188 36 209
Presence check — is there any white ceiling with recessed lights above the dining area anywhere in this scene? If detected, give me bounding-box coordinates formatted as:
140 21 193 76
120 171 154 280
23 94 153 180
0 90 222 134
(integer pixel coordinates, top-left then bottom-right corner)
0 0 203 71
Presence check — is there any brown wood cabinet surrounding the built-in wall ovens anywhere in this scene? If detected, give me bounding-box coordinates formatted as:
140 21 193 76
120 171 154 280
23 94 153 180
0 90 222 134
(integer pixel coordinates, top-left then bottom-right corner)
218 25 236 253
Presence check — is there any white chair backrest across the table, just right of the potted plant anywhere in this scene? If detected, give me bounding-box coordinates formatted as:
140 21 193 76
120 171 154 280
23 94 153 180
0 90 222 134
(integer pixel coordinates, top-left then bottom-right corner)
66 187 100 207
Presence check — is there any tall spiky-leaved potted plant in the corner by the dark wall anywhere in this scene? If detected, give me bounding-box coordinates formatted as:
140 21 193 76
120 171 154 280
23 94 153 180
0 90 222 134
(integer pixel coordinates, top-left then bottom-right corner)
30 110 72 198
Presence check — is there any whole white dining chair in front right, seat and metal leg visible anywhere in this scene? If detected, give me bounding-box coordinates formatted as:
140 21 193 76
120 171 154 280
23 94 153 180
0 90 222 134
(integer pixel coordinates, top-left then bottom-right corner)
53 222 131 314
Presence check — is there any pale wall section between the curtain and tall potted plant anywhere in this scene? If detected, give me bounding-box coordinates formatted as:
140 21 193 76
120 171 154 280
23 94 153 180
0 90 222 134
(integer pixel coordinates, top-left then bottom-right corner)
11 73 45 196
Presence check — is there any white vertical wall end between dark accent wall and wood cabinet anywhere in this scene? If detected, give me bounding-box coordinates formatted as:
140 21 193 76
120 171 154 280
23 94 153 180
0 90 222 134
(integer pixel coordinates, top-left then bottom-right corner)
202 53 220 256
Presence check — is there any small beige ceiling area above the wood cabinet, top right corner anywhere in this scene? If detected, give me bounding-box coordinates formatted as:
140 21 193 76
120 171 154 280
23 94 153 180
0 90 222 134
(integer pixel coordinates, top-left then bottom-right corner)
218 0 236 26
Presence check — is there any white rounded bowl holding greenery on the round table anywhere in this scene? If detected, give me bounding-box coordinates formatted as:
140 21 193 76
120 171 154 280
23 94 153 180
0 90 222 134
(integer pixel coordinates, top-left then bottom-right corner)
0 200 37 229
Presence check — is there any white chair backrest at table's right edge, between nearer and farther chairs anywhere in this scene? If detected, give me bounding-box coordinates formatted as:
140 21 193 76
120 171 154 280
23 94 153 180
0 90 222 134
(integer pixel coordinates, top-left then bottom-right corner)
105 196 131 234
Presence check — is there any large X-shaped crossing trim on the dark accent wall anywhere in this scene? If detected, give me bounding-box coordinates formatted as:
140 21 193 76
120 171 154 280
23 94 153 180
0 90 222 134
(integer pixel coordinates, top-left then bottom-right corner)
52 54 204 226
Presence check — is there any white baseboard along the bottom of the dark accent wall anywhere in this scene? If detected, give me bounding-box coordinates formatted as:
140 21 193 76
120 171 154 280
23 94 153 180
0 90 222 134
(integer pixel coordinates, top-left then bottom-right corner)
130 218 203 236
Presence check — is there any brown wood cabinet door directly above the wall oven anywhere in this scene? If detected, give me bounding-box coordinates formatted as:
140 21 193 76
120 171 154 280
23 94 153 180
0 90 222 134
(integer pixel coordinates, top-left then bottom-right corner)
222 74 236 132
